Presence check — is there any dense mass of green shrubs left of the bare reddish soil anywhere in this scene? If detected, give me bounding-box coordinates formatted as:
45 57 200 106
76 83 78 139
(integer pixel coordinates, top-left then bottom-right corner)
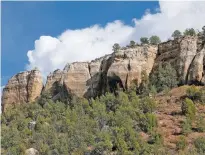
1 92 163 155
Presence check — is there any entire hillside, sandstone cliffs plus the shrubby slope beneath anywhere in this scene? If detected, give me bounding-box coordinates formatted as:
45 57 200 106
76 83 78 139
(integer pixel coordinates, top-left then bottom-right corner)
1 29 205 155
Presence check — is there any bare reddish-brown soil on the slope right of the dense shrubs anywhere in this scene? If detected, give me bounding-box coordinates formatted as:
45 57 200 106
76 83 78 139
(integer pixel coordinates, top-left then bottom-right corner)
156 86 205 149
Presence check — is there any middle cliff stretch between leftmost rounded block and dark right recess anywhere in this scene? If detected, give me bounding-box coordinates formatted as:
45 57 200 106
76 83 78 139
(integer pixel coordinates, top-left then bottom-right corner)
41 45 157 98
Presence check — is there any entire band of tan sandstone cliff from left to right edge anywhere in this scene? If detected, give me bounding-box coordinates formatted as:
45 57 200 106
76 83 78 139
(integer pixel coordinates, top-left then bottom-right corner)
2 36 205 107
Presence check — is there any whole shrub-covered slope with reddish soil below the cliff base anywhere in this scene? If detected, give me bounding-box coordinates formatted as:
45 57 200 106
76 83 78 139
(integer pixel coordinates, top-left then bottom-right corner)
1 86 205 155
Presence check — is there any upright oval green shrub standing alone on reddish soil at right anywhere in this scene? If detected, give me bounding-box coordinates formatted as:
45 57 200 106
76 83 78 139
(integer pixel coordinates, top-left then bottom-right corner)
181 98 196 120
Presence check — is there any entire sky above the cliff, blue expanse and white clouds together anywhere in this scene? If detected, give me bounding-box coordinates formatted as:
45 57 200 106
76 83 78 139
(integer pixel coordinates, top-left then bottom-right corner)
1 1 205 88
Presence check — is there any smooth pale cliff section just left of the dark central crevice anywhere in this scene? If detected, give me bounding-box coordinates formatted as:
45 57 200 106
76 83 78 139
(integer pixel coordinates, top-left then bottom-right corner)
44 56 112 98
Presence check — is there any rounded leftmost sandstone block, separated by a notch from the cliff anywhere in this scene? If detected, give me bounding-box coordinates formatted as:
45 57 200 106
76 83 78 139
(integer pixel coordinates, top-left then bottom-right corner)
2 70 43 109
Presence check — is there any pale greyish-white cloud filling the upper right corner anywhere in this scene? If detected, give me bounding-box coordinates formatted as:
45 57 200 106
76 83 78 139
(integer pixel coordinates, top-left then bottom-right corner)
133 1 205 40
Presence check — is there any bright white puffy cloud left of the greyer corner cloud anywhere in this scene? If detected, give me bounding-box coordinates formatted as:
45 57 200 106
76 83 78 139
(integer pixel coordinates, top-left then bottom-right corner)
27 21 134 74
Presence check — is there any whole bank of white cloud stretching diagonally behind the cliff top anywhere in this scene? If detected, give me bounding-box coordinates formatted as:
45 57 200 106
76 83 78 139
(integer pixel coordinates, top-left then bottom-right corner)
27 1 205 75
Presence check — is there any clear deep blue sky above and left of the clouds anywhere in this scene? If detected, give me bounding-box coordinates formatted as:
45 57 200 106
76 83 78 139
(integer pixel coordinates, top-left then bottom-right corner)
1 2 158 85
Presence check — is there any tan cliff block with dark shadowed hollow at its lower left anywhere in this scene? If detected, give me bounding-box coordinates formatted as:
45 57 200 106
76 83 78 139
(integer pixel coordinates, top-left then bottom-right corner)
107 45 157 89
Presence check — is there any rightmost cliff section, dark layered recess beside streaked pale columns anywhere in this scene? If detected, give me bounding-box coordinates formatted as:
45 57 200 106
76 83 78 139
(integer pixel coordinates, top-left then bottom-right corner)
155 36 205 84
